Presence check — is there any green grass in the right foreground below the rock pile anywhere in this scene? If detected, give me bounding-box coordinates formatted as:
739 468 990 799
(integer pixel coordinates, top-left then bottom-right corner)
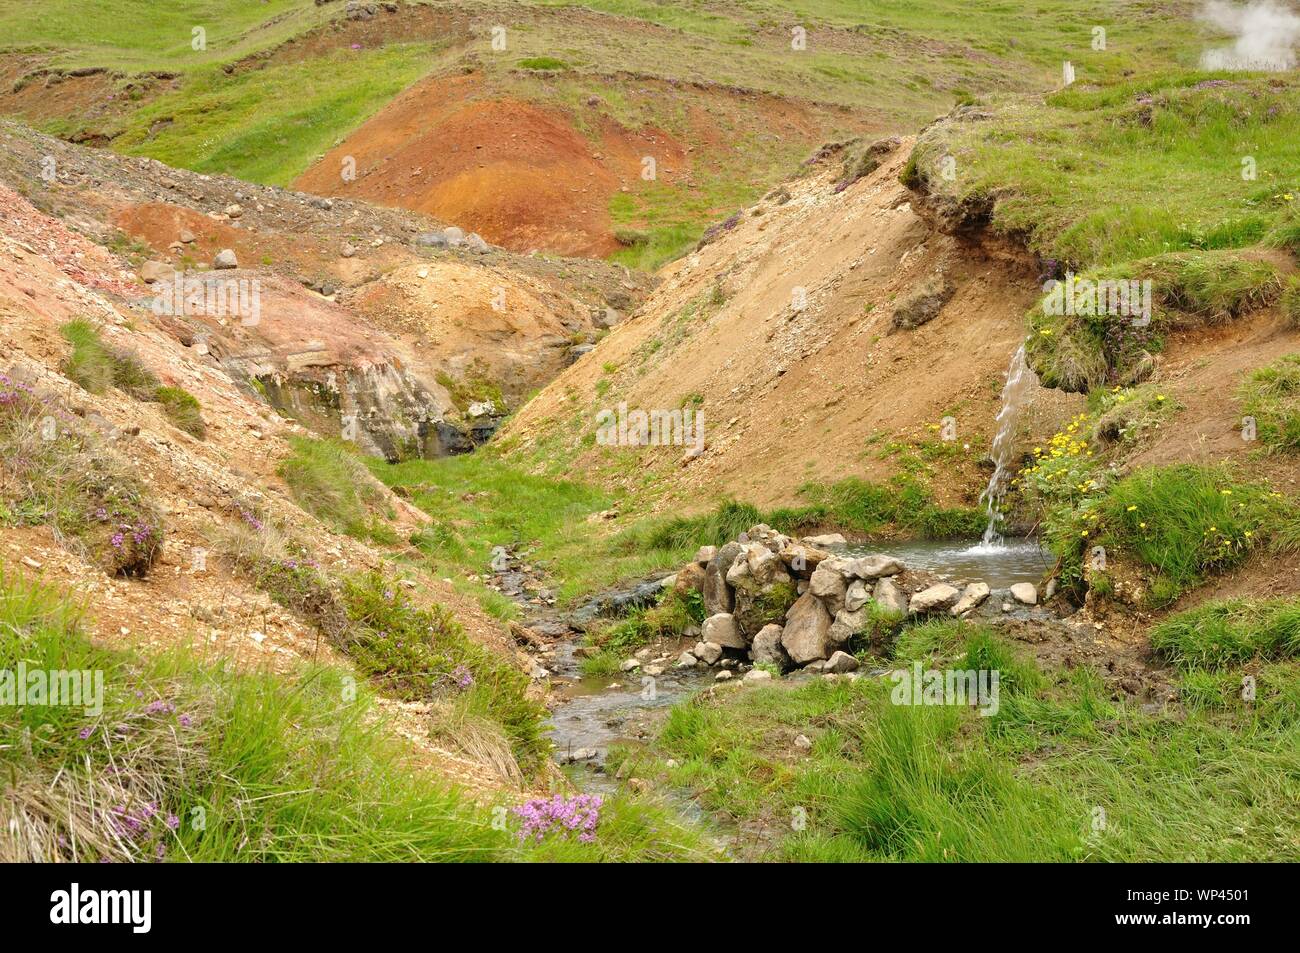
634 623 1300 862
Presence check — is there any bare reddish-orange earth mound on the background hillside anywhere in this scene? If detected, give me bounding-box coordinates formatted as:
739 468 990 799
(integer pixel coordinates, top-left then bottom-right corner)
295 74 689 257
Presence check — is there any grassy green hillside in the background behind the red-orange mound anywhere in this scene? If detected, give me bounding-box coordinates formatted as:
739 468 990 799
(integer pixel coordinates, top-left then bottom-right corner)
0 0 1203 268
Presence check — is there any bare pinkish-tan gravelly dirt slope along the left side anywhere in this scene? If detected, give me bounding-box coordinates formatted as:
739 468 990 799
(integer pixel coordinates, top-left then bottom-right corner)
0 178 535 789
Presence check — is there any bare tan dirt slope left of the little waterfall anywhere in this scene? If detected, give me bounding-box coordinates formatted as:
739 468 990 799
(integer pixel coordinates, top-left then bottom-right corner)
504 142 1071 508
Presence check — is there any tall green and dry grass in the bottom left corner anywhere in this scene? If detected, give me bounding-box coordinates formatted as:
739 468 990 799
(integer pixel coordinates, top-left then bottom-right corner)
0 564 714 862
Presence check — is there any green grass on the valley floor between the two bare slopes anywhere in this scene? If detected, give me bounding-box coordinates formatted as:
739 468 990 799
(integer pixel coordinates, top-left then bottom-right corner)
379 449 984 616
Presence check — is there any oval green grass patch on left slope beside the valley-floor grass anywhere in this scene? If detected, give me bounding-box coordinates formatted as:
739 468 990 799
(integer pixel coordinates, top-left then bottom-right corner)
278 437 398 545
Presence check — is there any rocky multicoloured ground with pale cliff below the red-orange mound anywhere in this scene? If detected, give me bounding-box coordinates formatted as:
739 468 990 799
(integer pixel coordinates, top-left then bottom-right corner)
0 124 649 459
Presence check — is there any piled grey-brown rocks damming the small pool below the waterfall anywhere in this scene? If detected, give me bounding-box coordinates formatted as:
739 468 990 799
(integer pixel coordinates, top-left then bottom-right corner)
672 524 1037 673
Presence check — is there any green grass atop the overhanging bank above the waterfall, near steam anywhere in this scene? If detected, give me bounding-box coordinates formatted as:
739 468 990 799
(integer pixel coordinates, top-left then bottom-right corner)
914 72 1300 272
